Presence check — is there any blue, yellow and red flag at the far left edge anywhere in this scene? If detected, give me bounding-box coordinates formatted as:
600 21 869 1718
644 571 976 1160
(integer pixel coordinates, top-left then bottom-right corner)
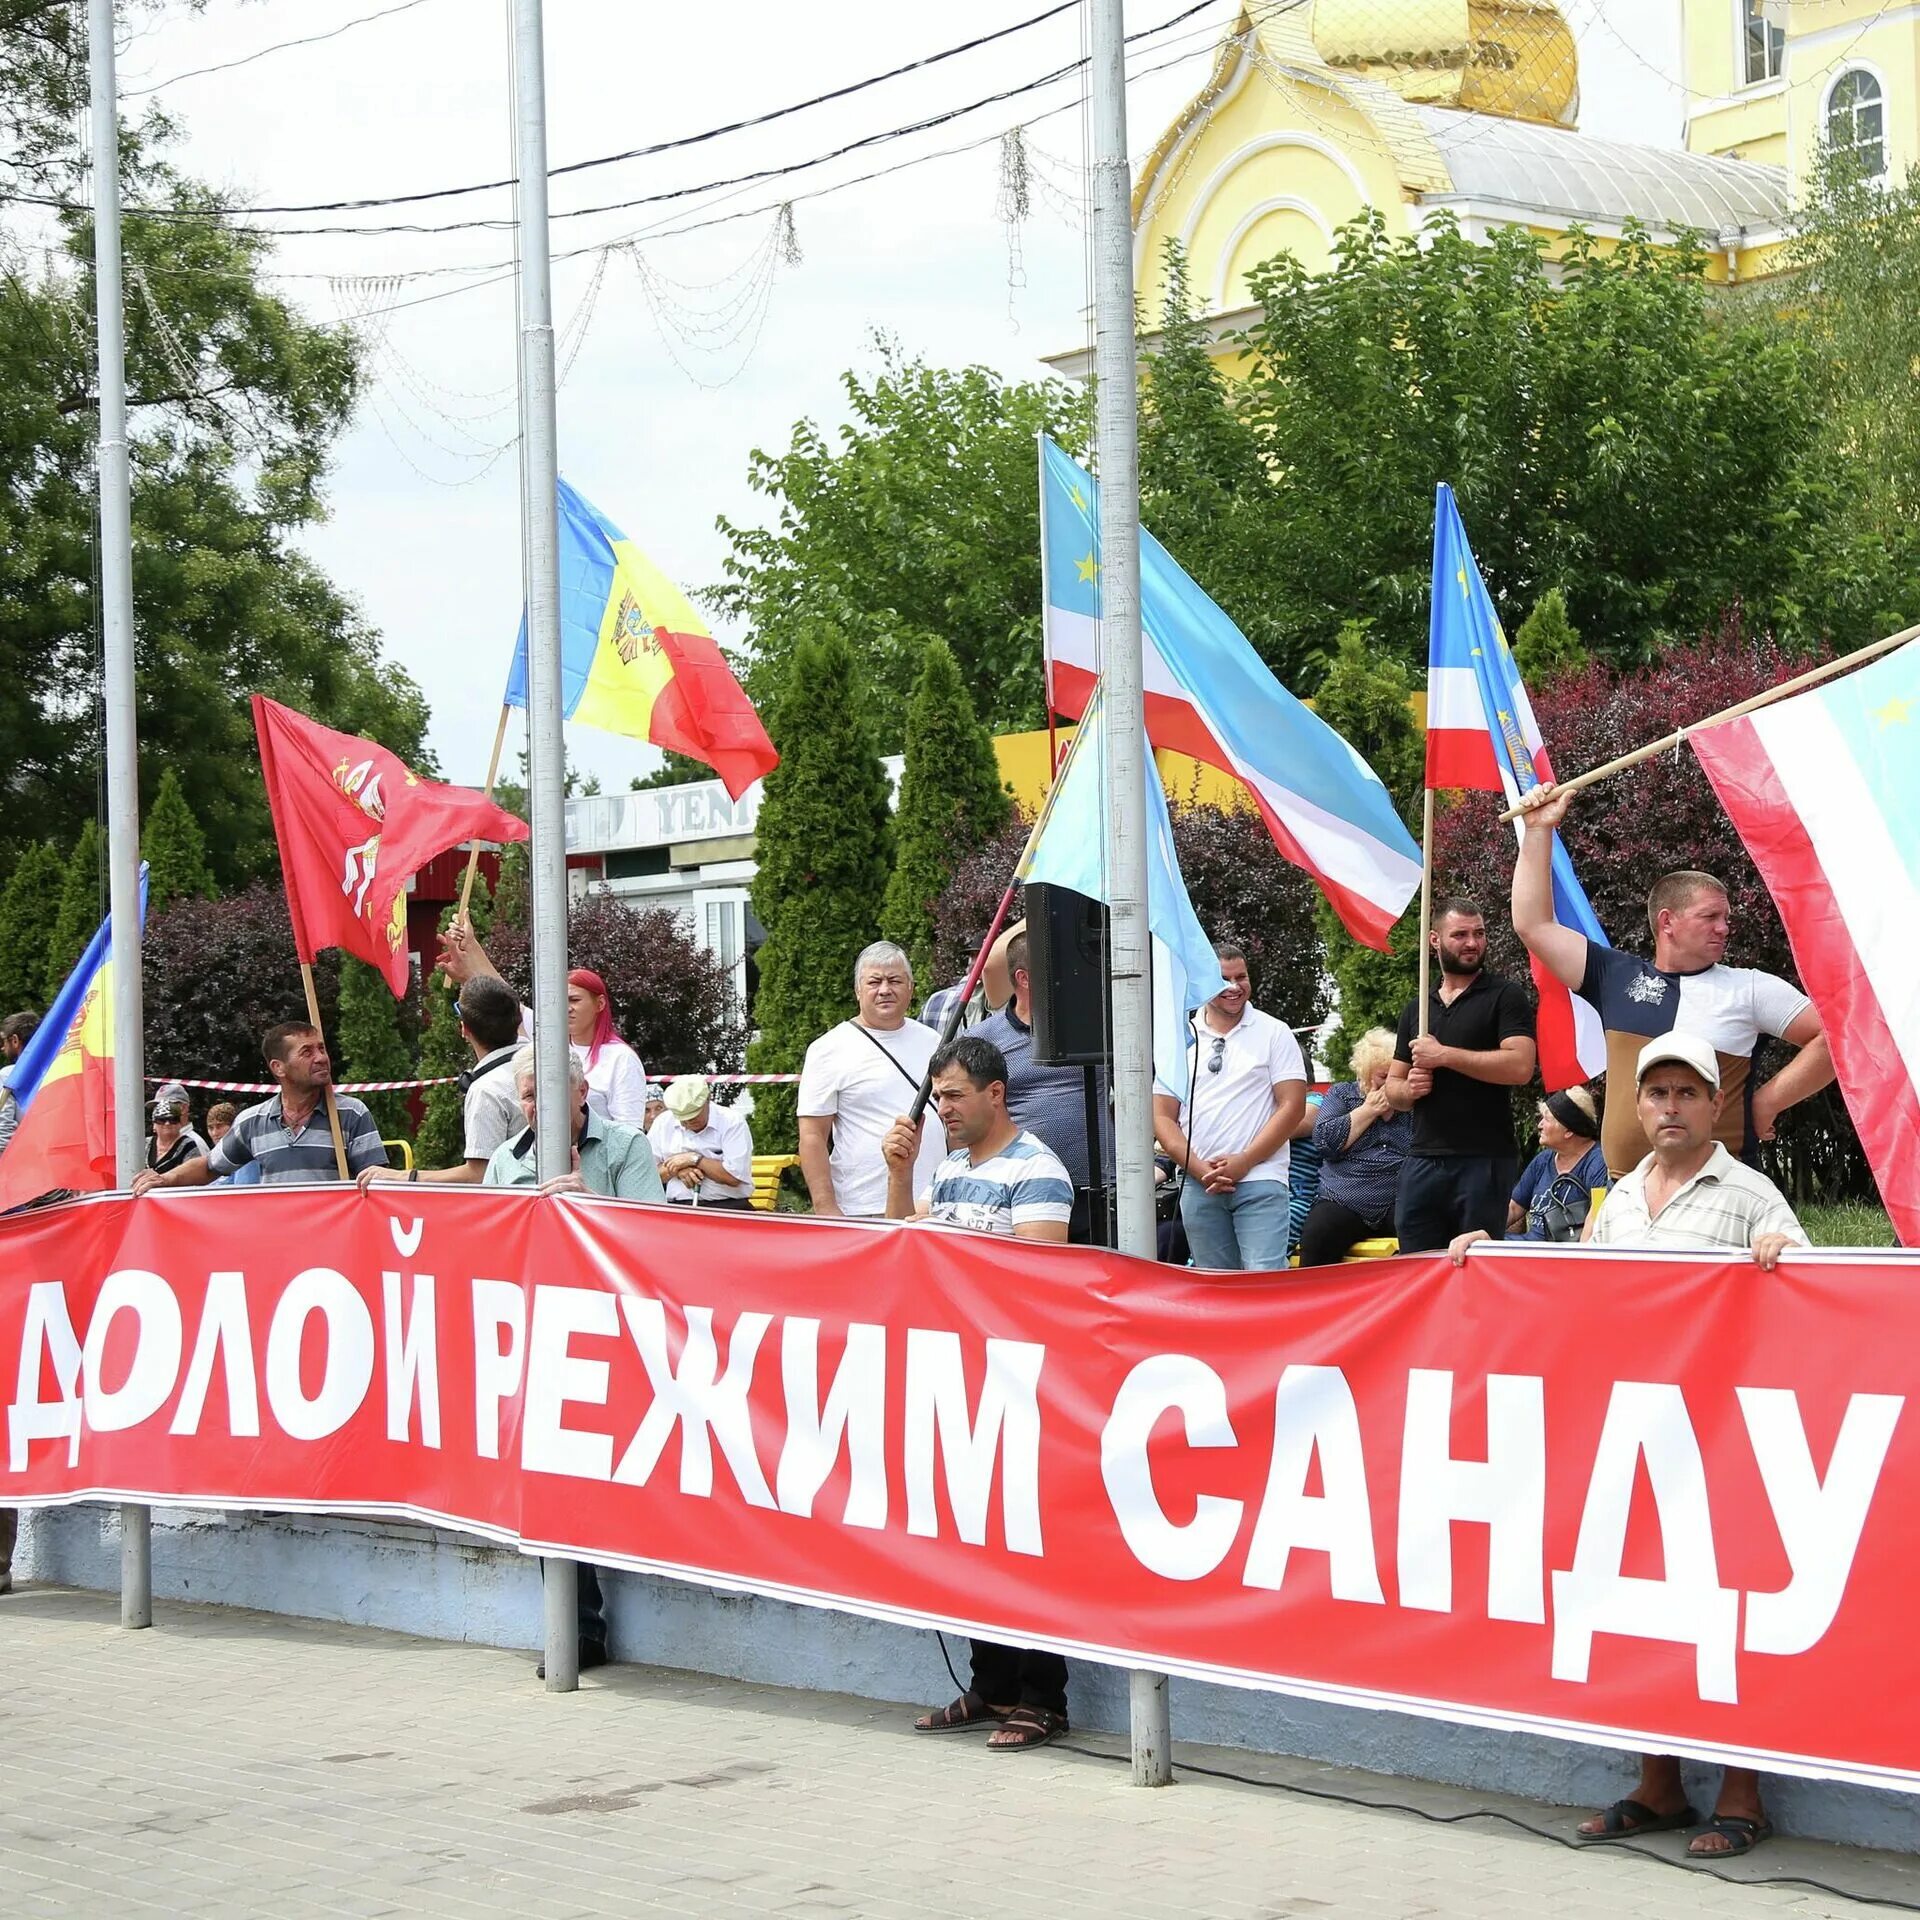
0 866 146 1213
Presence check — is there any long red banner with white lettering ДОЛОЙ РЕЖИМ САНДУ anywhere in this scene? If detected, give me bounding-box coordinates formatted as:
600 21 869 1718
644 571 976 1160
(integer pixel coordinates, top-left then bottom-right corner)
0 1188 1920 1788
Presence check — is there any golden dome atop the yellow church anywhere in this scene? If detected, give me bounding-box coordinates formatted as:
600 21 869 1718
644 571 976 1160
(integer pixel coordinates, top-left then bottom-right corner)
1311 0 1580 127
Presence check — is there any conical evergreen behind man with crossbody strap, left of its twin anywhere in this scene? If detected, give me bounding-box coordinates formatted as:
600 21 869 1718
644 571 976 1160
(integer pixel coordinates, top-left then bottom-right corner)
747 622 893 1152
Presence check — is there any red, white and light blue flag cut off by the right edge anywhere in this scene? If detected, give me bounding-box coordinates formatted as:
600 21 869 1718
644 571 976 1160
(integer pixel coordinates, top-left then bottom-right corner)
1688 645 1920 1246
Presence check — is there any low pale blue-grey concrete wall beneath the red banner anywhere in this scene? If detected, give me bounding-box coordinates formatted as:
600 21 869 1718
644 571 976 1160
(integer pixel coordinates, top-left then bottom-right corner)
13 1507 1920 1853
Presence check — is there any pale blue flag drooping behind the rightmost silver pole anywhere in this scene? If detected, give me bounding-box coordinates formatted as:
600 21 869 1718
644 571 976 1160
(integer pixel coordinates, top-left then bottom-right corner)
1020 689 1227 1092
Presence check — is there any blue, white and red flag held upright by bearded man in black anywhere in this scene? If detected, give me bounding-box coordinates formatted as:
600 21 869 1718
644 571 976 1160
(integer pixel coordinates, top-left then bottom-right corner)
1427 480 1611 1092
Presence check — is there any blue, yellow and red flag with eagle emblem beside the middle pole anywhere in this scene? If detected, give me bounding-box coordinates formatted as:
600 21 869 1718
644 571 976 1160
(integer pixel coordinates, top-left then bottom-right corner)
505 480 780 801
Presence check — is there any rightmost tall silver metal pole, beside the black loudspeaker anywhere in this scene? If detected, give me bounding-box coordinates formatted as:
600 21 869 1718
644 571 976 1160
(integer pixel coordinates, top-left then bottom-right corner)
1089 0 1173 1788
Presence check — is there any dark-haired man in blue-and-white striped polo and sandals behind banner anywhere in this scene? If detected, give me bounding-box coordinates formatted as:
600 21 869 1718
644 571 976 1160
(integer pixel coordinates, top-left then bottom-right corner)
881 1033 1073 1753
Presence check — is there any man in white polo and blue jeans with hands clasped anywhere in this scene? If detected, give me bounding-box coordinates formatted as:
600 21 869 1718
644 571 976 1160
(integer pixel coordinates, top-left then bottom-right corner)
1154 941 1308 1273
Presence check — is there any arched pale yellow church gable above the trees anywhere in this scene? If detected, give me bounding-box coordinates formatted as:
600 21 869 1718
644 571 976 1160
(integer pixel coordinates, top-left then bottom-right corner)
1137 67 1409 319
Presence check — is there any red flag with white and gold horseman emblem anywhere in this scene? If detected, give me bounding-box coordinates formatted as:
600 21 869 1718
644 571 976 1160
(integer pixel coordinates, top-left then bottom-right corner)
253 693 526 995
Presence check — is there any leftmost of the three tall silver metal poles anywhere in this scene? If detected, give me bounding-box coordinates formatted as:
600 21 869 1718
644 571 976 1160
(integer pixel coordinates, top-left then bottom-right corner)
86 0 154 1626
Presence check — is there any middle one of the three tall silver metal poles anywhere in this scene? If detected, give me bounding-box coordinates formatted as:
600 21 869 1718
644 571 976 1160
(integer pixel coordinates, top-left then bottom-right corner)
513 0 580 1693
